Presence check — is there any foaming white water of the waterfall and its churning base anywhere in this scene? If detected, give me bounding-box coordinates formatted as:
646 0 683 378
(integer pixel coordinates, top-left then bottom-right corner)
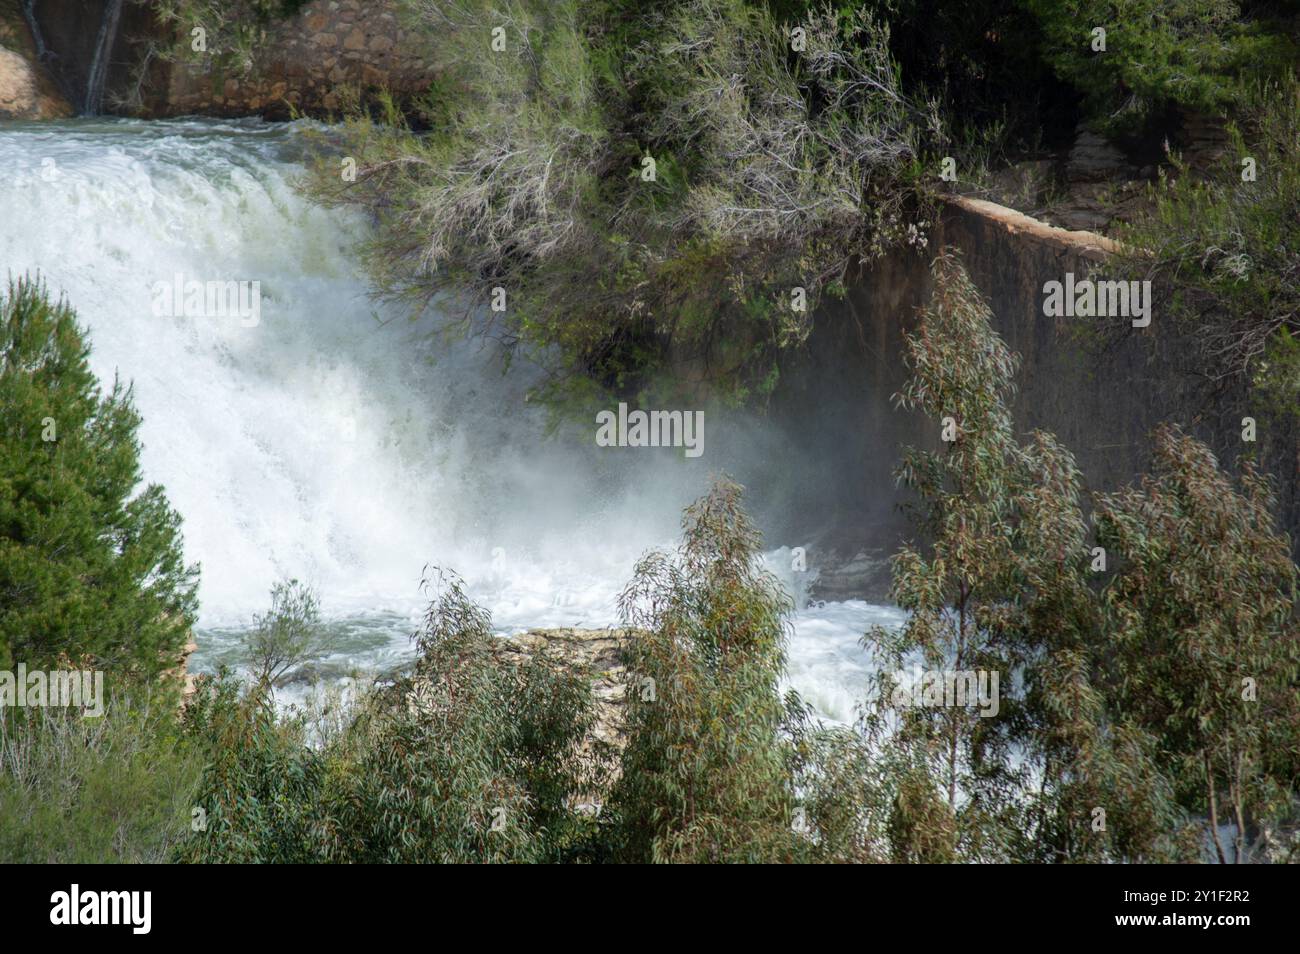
0 121 900 720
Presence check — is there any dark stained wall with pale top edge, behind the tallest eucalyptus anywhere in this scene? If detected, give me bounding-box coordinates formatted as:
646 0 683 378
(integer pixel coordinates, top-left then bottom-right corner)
775 199 1300 579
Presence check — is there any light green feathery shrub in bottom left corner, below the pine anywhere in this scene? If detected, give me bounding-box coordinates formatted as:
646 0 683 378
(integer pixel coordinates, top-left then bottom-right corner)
0 689 202 864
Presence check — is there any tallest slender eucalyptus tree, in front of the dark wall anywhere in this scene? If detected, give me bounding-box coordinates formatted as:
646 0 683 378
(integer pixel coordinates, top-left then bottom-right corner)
863 251 1190 860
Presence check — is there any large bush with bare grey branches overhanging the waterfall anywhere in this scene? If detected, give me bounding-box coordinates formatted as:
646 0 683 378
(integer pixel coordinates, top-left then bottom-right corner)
309 0 937 410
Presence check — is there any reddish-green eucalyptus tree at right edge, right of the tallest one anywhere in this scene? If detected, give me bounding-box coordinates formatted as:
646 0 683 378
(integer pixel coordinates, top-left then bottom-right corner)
1097 426 1300 862
